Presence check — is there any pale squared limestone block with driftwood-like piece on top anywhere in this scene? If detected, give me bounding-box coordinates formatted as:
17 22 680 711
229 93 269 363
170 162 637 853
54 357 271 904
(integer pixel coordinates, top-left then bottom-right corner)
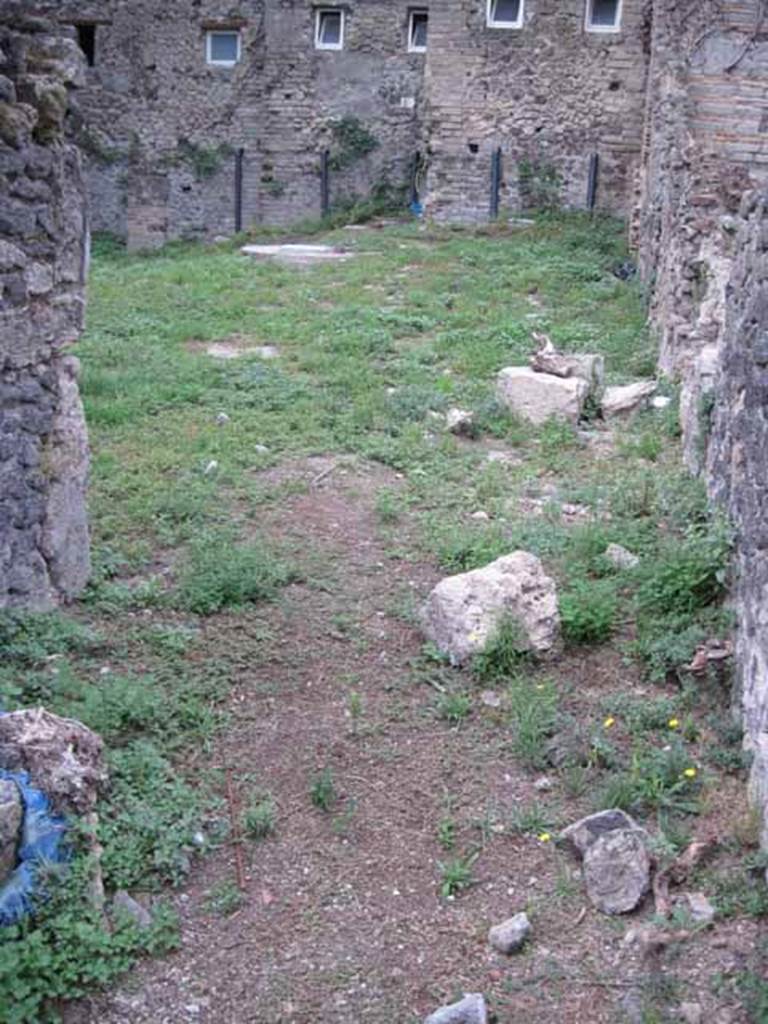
497 367 590 424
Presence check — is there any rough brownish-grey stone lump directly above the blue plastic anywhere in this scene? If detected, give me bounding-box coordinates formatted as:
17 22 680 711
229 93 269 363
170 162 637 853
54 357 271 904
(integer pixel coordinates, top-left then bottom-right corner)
0 708 108 814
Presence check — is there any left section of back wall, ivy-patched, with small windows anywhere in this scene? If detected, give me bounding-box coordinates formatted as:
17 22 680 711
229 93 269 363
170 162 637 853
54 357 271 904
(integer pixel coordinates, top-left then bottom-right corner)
47 0 424 249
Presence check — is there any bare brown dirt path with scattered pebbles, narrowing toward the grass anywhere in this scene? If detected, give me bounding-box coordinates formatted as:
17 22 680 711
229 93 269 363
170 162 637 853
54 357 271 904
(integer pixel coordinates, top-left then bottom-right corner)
66 459 759 1024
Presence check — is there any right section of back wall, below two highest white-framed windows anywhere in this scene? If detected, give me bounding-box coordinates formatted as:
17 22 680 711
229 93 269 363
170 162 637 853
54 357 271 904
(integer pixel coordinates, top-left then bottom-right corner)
425 0 650 222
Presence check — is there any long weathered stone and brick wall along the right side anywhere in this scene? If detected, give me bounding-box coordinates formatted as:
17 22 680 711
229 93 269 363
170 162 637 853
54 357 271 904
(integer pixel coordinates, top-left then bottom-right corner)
637 0 768 846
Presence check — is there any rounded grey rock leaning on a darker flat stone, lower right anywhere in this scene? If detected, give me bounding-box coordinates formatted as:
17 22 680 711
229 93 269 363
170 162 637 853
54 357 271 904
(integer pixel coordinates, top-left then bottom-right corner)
584 828 650 914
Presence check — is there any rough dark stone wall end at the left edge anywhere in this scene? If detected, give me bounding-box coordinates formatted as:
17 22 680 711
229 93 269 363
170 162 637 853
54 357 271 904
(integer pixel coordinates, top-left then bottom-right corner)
0 0 89 609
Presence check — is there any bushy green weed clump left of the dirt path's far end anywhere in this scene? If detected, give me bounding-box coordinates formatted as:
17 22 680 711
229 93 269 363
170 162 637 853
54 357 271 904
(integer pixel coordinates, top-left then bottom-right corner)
175 535 297 615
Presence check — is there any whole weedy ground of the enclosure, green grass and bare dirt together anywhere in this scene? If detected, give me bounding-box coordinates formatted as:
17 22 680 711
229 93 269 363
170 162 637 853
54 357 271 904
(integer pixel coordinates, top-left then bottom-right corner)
0 211 768 1024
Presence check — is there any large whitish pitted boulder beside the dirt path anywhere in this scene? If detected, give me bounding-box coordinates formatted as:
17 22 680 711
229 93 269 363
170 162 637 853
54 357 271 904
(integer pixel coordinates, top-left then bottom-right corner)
423 551 560 665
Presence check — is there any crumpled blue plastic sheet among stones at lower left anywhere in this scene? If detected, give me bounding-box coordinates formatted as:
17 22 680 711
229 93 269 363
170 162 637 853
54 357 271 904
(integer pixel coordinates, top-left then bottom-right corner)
0 768 68 925
